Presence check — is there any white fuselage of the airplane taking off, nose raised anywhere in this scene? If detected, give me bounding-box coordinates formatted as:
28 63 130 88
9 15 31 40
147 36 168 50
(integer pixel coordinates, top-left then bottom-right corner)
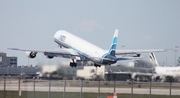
54 30 107 63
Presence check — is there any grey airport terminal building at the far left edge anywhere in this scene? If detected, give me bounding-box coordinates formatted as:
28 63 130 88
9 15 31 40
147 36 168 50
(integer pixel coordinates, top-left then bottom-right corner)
0 52 40 76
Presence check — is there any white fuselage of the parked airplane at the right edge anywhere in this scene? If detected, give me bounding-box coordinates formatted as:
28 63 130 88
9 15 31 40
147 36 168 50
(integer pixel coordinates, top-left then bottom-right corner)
155 67 180 77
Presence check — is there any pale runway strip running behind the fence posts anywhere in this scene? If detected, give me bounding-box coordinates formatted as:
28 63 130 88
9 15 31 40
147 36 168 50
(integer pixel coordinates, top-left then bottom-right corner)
0 84 180 95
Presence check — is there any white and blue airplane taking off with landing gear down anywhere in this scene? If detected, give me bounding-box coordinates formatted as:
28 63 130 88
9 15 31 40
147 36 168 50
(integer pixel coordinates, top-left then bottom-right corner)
8 29 172 67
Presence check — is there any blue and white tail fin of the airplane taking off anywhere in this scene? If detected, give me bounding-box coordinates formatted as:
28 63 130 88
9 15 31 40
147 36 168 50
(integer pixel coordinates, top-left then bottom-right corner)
109 29 118 56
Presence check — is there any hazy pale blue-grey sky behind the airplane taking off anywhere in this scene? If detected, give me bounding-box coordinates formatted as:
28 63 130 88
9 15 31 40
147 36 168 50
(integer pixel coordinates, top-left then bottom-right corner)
0 0 180 65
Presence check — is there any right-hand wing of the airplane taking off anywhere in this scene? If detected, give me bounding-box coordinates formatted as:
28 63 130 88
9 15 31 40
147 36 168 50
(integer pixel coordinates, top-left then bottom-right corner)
116 49 173 55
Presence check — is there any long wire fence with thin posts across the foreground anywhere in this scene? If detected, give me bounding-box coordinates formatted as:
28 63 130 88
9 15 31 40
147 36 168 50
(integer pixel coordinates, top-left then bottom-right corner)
0 77 180 98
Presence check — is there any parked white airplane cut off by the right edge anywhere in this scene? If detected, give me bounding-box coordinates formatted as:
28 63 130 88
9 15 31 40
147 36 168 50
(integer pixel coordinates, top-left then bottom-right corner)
150 53 180 82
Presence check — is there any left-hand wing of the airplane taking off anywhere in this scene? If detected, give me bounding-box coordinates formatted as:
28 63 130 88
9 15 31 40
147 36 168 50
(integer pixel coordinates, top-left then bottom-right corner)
8 48 79 57
